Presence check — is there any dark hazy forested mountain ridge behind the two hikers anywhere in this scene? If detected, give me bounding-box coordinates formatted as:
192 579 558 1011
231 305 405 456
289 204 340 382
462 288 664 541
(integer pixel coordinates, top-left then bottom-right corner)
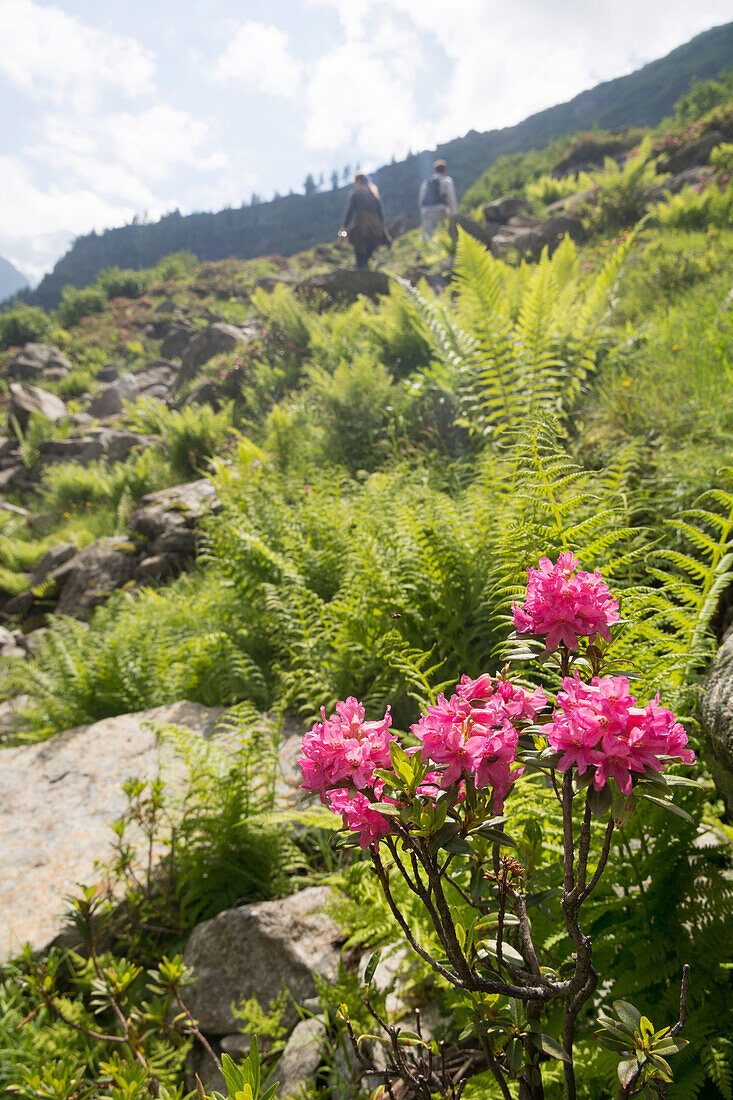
23 23 733 308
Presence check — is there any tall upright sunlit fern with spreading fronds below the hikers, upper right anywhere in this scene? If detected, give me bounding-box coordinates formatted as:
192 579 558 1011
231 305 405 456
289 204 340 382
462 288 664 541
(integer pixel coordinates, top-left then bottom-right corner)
408 232 631 436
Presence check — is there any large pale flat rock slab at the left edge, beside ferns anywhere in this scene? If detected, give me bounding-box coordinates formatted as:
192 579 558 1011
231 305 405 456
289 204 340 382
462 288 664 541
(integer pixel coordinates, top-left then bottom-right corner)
0 703 222 959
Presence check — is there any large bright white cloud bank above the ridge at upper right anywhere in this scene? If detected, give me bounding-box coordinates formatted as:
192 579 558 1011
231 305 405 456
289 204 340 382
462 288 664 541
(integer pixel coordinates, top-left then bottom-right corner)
306 0 730 157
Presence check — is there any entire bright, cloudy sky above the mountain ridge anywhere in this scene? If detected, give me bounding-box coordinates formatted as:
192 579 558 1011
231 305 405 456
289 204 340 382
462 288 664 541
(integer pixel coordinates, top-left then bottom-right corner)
0 0 731 282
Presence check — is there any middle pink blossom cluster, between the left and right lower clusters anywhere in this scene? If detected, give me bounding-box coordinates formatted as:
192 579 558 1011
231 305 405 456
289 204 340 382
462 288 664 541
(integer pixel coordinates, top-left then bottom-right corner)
412 675 547 813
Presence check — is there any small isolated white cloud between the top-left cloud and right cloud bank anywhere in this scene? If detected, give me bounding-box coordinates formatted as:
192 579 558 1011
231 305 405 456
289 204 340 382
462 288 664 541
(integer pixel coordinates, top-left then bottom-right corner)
214 22 300 98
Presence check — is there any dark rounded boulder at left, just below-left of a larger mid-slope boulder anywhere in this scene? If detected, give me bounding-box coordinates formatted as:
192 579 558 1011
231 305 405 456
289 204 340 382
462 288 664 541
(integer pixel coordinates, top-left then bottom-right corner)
55 538 138 618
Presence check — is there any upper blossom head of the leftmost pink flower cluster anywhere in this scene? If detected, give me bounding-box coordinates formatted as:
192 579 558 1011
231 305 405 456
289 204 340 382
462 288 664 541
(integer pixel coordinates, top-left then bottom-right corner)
298 696 396 802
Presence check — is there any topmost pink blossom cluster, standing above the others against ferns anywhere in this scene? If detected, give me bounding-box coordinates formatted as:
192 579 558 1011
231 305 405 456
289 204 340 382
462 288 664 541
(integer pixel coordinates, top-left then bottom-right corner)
512 553 619 652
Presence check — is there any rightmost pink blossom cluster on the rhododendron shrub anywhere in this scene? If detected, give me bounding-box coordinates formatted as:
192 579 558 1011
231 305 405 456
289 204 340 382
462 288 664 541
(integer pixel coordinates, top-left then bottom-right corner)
545 675 694 794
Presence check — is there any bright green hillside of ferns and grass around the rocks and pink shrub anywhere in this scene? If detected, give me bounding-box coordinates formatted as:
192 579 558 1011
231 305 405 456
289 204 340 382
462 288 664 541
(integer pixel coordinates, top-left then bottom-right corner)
0 88 733 1100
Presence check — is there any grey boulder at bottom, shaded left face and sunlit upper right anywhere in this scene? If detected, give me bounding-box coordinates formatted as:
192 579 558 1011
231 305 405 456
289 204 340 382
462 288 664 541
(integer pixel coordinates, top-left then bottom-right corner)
184 887 341 1036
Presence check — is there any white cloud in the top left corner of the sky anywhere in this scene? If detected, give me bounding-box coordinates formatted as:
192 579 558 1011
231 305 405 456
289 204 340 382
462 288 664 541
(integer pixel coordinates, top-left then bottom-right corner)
0 0 154 101
